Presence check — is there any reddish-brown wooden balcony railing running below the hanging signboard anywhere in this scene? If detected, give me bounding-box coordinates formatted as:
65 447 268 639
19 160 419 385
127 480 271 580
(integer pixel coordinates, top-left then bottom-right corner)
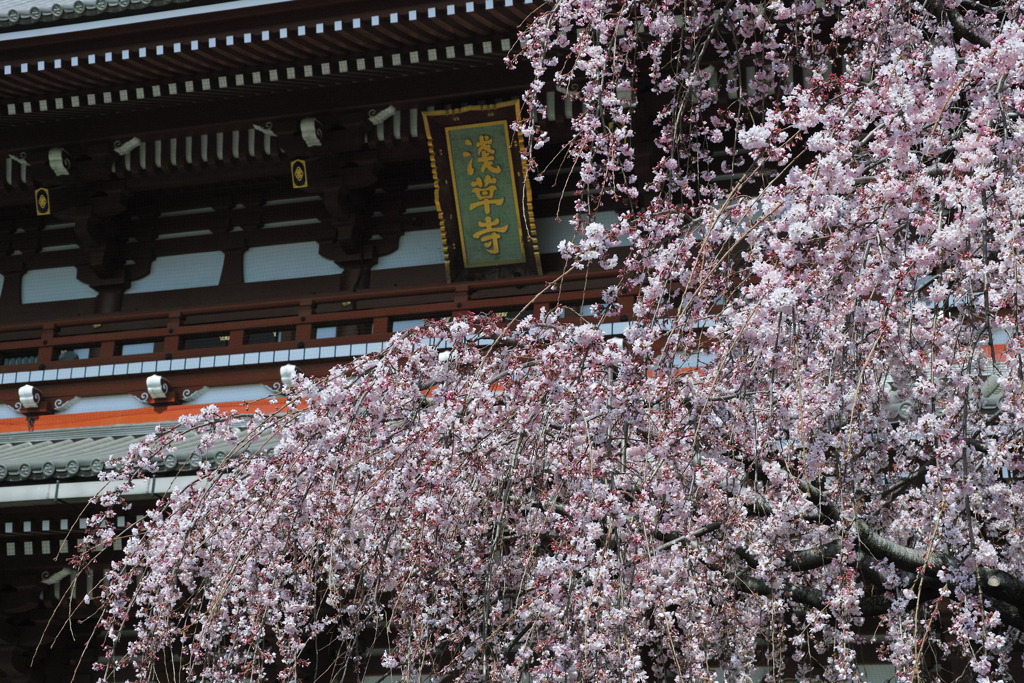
0 272 610 372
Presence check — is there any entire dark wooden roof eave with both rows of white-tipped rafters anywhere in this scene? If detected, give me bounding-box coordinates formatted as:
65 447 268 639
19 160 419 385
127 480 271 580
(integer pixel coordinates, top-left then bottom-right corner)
0 0 539 157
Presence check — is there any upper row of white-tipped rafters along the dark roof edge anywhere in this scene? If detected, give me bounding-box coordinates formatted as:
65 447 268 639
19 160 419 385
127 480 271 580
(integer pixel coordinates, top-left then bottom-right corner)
0 0 537 104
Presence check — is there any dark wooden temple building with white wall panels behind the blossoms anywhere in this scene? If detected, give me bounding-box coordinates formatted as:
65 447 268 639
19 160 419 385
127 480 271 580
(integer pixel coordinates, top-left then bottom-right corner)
0 0 622 682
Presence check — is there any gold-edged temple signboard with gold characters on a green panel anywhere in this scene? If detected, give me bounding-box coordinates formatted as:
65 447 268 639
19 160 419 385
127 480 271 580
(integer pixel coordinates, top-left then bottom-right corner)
423 101 541 282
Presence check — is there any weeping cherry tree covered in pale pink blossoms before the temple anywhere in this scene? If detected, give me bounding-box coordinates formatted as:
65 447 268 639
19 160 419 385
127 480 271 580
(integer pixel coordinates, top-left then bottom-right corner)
66 0 1024 683
